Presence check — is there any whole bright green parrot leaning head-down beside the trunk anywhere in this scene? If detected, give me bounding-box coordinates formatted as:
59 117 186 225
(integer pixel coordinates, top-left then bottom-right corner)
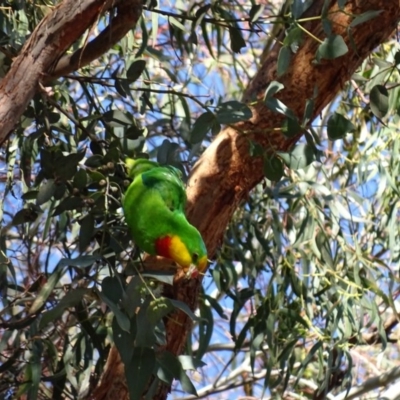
123 158 207 277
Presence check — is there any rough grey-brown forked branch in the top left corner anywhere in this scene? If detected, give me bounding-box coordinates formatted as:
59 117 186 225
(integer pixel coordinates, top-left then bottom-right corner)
0 0 142 144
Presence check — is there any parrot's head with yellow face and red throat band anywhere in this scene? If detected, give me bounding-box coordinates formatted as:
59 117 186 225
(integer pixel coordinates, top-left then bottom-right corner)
155 226 207 278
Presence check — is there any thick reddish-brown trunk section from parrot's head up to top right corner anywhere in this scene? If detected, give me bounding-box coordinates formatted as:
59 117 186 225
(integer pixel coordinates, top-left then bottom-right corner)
188 0 400 255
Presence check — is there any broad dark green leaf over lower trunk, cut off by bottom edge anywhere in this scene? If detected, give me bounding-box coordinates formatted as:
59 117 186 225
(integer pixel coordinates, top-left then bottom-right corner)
125 347 156 400
